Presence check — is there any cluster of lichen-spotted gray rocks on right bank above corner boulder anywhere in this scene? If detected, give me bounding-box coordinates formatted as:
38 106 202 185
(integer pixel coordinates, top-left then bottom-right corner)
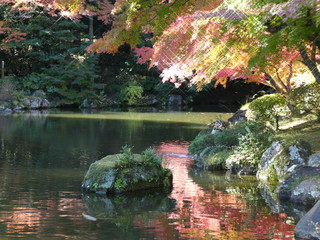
257 141 320 205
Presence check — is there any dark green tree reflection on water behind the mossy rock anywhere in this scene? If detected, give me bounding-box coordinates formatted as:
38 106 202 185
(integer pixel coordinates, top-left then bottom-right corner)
0 114 197 170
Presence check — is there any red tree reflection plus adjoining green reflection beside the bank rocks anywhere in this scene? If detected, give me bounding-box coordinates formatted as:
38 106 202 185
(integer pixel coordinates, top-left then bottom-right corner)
152 143 294 239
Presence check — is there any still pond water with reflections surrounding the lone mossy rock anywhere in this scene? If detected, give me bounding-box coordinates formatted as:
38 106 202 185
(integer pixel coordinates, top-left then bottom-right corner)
0 112 294 240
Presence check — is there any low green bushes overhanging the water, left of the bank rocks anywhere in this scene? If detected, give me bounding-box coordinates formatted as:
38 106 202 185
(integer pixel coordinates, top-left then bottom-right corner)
189 121 274 172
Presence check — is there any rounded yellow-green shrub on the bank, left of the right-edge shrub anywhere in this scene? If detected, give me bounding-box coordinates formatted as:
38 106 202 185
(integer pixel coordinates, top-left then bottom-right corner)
248 93 289 129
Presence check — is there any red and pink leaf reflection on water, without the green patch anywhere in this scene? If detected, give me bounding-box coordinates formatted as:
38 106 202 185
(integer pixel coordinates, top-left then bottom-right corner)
151 142 295 240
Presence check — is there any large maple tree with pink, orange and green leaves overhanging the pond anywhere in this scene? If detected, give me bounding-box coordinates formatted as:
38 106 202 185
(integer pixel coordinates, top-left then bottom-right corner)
88 0 320 95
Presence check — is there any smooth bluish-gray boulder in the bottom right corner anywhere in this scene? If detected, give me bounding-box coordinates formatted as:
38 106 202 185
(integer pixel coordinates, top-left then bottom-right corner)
294 201 320 239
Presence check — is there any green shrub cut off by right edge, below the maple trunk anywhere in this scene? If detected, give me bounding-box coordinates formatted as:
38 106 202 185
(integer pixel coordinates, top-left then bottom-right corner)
287 82 320 119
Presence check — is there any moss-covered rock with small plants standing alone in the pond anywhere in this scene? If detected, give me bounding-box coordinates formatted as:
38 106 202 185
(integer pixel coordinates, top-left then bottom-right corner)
82 154 172 194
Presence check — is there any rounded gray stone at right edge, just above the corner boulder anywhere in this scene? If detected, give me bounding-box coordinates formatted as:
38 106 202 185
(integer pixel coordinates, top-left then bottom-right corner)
291 178 320 205
